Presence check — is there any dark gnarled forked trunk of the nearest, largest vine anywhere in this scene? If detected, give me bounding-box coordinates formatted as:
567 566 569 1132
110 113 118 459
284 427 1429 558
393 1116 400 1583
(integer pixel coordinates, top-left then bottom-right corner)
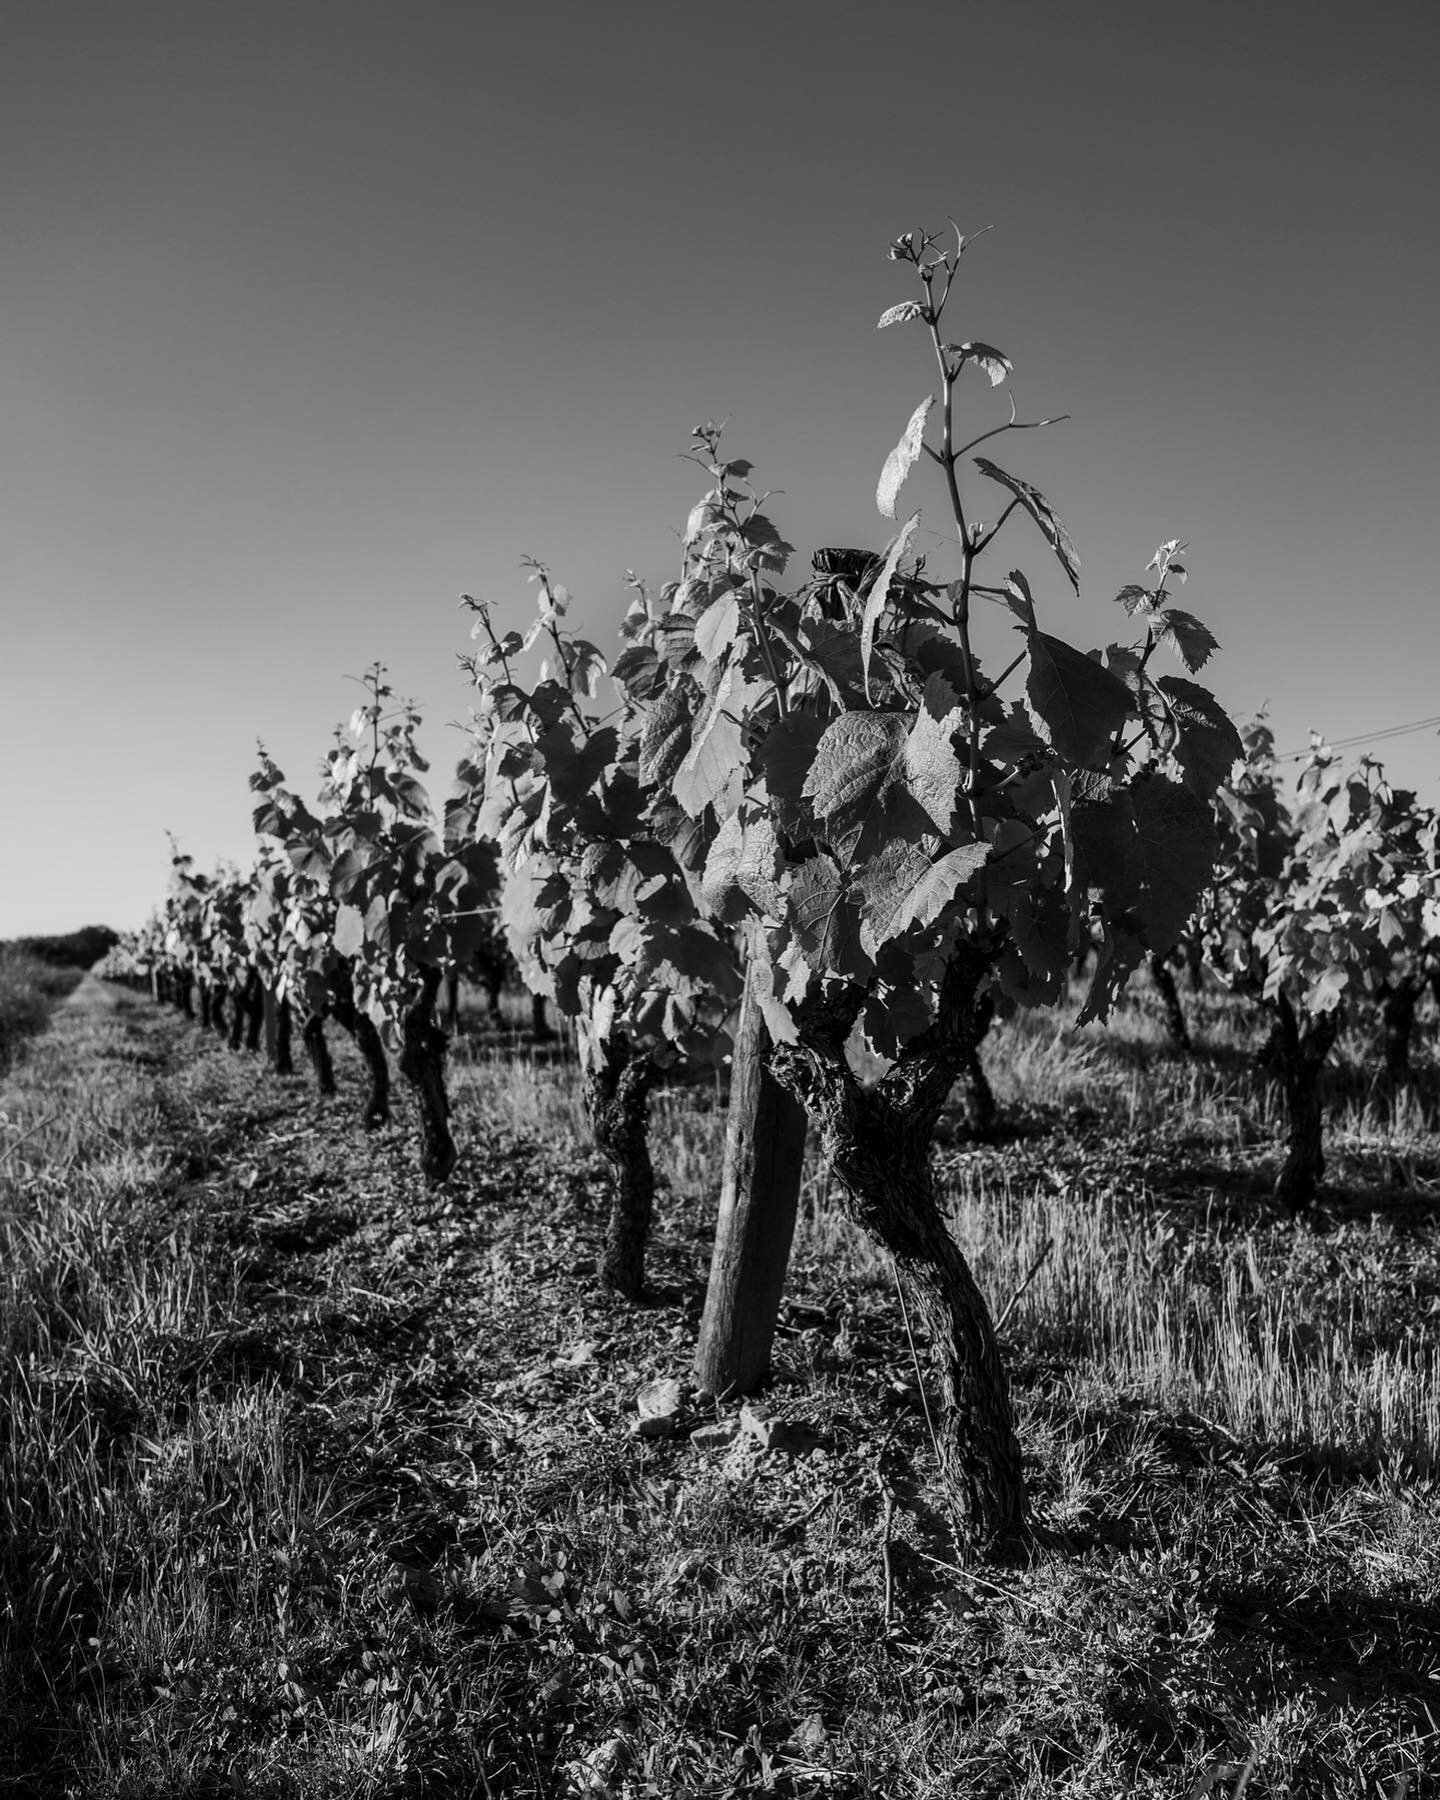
770 945 1030 1544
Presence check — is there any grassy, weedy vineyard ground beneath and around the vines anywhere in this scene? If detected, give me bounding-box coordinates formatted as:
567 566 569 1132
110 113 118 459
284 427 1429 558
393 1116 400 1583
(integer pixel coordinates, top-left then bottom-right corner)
0 983 1440 1800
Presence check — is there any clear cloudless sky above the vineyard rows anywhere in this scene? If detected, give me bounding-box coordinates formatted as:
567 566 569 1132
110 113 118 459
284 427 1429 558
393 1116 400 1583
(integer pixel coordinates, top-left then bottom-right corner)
0 0 1440 938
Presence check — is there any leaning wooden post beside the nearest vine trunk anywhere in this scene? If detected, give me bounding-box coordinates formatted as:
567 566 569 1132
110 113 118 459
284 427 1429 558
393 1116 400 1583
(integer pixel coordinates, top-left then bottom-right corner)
695 977 806 1395
